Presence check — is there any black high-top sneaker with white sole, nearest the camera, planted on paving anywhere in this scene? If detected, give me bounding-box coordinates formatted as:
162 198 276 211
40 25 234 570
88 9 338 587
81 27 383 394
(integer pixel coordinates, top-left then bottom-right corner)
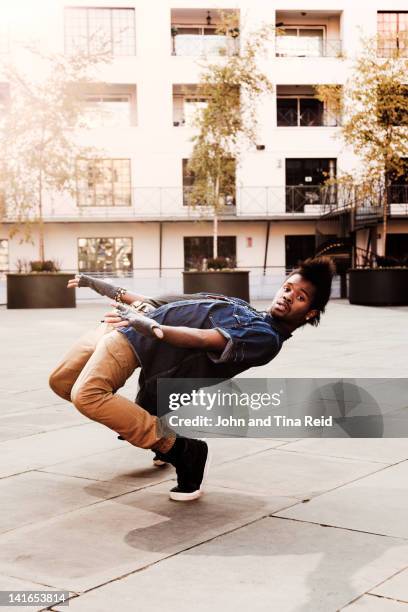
169 438 210 501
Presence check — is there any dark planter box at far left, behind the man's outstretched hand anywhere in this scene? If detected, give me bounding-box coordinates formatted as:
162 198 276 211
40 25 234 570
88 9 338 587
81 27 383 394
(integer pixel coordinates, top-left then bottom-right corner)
7 272 76 308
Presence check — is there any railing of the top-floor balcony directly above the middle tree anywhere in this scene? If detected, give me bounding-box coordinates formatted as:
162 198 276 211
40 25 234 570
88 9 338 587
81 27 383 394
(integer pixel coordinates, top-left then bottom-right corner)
172 34 239 57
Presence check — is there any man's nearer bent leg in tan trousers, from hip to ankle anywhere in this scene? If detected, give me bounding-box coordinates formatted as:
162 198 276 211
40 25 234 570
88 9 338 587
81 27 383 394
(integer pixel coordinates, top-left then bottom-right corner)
71 331 175 453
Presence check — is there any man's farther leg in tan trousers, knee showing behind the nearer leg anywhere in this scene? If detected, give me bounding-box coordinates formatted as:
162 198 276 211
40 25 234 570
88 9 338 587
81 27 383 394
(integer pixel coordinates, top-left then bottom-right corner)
49 323 113 402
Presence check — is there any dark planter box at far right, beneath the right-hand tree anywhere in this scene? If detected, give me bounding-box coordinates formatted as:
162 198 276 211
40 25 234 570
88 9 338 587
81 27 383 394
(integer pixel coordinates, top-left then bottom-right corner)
349 268 408 306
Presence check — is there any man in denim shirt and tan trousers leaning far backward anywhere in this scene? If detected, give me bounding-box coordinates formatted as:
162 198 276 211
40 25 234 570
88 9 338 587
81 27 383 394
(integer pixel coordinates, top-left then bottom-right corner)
50 257 334 501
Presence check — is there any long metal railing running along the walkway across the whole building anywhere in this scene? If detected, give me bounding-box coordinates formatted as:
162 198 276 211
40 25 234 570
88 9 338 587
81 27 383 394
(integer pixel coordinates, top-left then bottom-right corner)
3 185 408 222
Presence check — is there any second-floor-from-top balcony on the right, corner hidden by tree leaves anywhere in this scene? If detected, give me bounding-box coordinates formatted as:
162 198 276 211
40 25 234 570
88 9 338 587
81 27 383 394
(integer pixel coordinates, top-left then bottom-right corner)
276 85 341 127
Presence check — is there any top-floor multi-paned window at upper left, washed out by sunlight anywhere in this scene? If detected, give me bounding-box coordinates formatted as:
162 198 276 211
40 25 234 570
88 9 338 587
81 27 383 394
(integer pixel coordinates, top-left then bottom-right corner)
65 7 136 55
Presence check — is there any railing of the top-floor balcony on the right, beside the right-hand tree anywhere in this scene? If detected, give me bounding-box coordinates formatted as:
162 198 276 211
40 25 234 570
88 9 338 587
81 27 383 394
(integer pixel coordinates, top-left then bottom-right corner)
275 34 342 57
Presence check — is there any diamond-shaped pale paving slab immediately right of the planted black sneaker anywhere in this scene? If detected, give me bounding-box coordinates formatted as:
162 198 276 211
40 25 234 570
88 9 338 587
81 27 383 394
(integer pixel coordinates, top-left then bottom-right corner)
211 447 382 499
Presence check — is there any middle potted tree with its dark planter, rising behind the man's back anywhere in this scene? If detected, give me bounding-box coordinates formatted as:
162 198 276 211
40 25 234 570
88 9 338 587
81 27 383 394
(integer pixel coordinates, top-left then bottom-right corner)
183 17 273 299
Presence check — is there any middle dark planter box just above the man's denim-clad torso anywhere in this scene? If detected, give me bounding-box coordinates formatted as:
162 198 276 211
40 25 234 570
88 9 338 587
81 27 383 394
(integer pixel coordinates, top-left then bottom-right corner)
183 270 249 302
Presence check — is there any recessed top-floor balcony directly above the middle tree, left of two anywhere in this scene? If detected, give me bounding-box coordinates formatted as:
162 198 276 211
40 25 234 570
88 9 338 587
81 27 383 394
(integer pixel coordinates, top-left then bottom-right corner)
171 9 239 57
